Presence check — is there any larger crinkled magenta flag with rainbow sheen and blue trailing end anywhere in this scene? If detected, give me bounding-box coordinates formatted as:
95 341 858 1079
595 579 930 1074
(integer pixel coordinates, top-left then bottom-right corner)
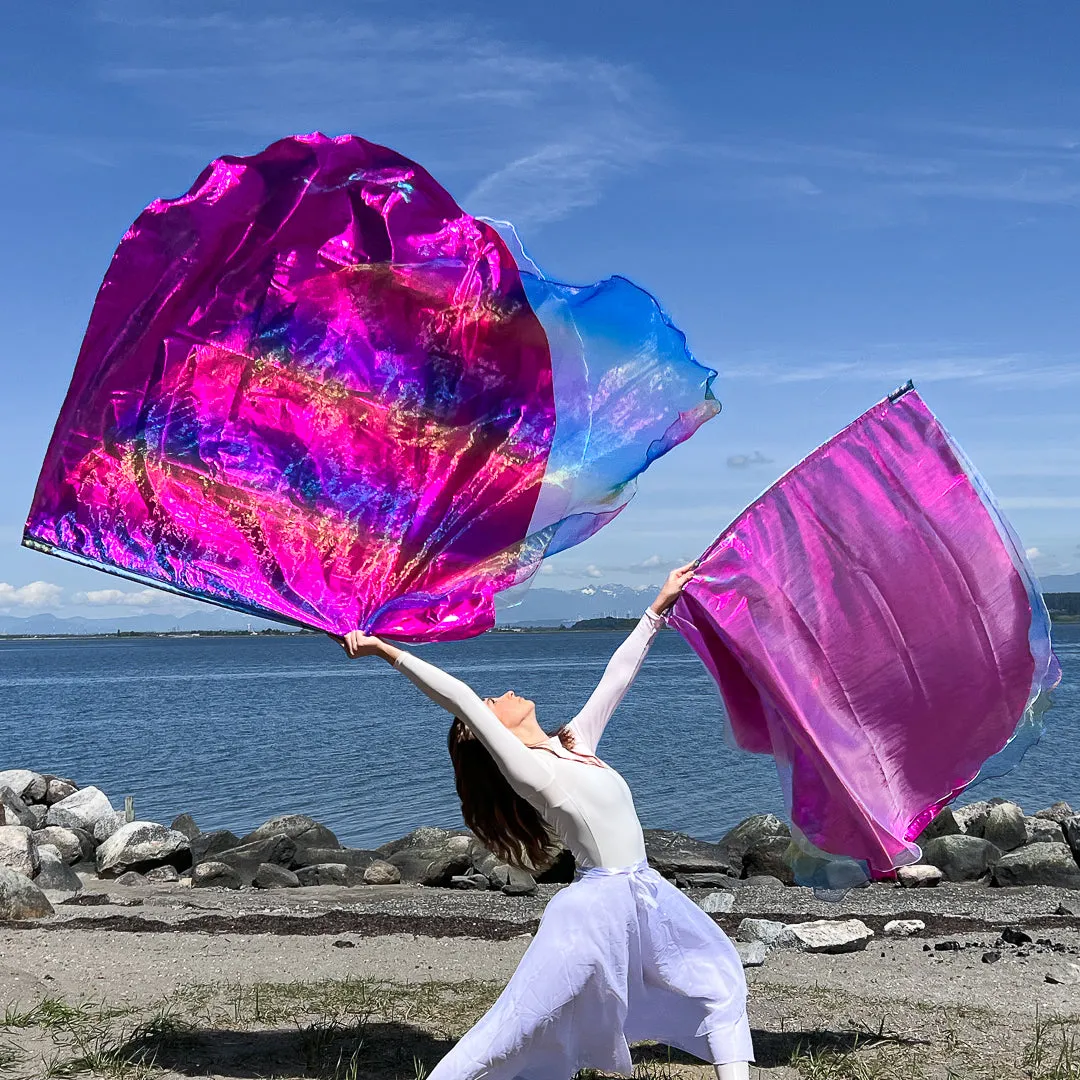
24 135 718 640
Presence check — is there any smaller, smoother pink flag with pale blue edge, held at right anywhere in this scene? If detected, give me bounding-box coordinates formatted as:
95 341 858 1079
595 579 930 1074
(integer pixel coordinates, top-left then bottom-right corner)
673 390 1061 889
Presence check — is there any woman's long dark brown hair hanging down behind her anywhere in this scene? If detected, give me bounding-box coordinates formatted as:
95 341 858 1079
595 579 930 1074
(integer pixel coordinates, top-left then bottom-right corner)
446 718 573 872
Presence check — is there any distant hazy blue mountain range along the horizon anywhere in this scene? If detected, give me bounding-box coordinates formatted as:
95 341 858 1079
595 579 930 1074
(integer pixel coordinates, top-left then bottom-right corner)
0 573 1080 635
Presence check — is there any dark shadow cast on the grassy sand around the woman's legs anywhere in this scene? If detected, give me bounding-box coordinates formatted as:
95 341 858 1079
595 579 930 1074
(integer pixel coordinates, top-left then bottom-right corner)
107 1023 917 1080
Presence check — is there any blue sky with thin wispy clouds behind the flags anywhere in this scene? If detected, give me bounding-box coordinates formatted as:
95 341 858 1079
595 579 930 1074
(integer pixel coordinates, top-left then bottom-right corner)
0 0 1080 615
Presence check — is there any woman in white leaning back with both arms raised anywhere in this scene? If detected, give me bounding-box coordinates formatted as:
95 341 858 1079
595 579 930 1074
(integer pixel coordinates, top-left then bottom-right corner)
343 565 753 1080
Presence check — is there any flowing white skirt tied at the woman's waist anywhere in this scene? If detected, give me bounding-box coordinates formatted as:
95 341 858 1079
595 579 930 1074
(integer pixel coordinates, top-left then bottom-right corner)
431 862 754 1080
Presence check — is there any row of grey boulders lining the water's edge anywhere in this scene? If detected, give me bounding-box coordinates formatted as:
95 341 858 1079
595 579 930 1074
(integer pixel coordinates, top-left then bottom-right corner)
0 769 1080 921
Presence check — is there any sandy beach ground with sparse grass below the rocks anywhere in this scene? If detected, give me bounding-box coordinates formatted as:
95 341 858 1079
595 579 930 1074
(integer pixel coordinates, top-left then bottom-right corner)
0 886 1080 1080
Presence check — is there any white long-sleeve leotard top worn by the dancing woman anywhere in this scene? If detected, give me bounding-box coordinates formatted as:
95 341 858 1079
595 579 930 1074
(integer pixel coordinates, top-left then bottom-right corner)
394 610 664 869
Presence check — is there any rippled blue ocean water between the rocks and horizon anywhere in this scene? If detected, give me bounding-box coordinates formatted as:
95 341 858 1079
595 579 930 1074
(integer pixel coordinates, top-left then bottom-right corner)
0 625 1080 847
